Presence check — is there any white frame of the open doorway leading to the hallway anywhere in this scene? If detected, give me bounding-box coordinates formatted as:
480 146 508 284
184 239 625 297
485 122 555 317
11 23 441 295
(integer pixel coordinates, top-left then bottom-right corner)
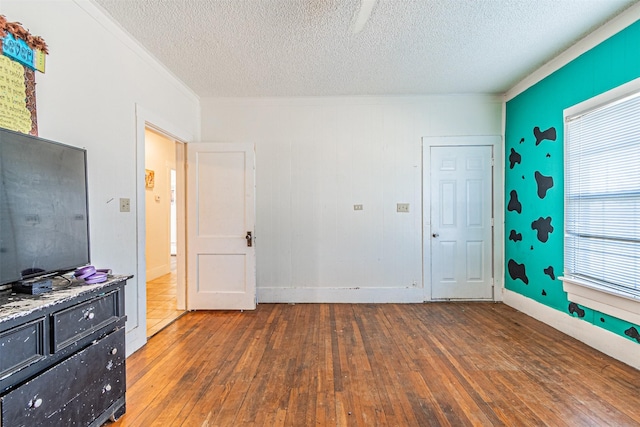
126 104 195 356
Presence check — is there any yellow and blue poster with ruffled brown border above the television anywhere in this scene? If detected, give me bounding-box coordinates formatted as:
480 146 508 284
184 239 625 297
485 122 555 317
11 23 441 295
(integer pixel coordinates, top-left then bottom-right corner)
0 15 49 135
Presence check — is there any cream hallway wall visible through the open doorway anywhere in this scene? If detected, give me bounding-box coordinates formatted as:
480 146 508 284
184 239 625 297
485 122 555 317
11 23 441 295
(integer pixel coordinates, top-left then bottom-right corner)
144 130 176 281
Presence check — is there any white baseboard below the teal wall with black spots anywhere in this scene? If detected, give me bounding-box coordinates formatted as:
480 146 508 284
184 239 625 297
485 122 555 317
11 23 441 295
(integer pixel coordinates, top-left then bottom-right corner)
503 289 640 369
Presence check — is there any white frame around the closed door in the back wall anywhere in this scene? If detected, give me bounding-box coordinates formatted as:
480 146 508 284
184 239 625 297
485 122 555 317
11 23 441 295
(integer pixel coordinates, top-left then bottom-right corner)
422 135 504 301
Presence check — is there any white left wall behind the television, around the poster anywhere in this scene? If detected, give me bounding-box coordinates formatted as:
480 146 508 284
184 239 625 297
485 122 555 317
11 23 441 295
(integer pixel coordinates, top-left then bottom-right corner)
0 0 199 353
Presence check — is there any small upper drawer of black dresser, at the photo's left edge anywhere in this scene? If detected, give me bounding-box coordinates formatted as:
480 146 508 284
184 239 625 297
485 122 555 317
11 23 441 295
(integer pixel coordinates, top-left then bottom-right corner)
0 317 47 378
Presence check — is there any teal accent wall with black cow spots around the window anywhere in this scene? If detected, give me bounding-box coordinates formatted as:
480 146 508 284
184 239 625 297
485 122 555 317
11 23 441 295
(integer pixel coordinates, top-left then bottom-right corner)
505 21 640 343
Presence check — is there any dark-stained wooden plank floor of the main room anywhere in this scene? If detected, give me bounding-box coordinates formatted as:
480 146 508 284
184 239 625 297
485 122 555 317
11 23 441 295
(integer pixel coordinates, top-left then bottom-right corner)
113 303 640 427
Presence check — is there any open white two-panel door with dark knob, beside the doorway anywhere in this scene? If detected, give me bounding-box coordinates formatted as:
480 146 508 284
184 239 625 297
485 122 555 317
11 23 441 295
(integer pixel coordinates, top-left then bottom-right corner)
187 143 256 310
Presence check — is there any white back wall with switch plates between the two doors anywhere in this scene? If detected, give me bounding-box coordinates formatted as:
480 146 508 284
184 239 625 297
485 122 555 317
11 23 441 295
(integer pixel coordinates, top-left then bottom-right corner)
201 95 502 302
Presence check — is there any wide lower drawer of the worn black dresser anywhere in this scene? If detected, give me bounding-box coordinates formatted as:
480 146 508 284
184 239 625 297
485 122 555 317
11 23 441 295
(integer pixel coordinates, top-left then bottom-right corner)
0 328 125 426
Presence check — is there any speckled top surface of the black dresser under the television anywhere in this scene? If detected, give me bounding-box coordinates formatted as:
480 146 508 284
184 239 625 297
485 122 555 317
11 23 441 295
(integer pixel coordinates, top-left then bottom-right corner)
0 274 133 323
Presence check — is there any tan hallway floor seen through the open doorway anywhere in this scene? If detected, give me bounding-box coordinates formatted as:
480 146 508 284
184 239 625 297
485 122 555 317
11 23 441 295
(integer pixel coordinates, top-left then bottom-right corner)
147 257 184 337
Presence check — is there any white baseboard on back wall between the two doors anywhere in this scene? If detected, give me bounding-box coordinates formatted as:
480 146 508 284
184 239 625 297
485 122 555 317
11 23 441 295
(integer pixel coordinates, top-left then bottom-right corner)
256 287 424 303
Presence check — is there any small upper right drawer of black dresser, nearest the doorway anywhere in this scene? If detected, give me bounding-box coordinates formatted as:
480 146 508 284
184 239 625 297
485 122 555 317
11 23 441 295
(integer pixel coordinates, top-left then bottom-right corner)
51 290 122 353
